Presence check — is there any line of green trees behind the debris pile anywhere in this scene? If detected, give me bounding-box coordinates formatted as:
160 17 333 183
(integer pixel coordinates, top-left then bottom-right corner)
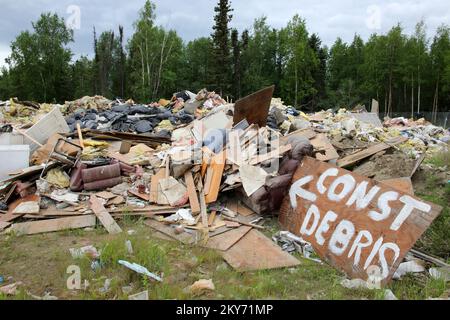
0 0 450 119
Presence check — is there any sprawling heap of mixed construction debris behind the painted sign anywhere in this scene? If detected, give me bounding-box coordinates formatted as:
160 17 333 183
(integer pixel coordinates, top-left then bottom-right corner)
0 87 450 296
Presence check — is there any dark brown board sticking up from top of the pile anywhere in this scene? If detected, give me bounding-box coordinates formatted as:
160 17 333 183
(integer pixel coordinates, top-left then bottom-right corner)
233 86 275 127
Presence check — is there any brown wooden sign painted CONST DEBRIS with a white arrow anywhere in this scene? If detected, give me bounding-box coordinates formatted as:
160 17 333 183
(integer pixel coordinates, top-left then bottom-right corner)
280 157 442 284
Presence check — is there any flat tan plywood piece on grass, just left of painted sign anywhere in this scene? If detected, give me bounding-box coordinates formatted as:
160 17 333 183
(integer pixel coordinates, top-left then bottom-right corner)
222 230 300 271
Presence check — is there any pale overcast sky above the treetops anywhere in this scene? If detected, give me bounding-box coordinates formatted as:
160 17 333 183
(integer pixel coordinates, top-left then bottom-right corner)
0 0 450 65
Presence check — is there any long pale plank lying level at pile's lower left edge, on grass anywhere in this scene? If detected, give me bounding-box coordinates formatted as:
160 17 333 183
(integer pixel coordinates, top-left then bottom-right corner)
8 215 96 235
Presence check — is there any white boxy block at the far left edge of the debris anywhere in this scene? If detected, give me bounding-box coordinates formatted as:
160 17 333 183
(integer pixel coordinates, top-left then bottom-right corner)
0 145 30 180
